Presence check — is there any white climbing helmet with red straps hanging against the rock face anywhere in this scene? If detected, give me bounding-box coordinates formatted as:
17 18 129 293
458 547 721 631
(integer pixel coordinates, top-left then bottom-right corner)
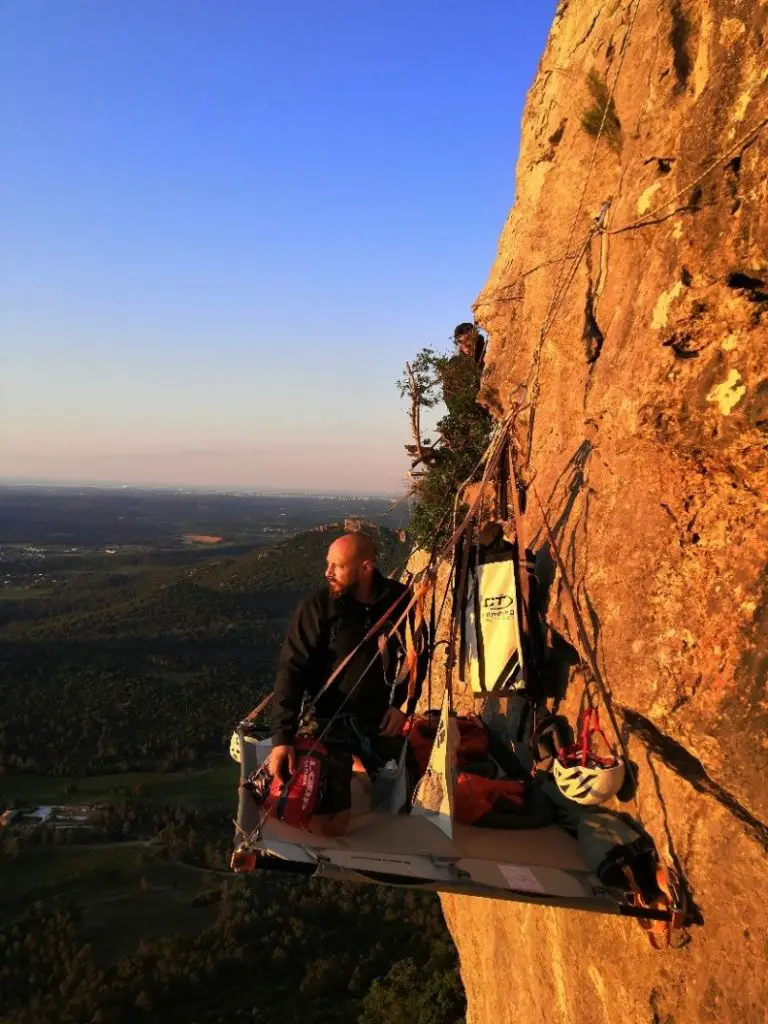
552 708 627 807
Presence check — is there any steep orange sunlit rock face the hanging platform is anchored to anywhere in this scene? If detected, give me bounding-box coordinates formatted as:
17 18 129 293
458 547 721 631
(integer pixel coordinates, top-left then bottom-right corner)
443 0 768 1024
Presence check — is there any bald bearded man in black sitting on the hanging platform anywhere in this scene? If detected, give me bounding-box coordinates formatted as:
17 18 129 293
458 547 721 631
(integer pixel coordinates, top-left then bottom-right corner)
268 534 427 835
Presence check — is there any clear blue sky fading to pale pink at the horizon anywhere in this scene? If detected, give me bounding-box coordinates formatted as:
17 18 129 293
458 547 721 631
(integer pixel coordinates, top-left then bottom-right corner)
0 0 555 493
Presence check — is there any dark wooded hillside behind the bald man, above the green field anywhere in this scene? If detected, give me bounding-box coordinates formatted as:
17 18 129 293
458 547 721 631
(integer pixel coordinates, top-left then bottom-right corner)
0 525 408 775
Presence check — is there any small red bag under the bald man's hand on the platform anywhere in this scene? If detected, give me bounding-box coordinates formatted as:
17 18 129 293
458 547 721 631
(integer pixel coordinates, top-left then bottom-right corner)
251 736 328 828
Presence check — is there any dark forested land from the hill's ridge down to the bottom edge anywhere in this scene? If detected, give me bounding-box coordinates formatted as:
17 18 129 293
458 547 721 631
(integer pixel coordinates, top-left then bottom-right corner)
0 523 465 1024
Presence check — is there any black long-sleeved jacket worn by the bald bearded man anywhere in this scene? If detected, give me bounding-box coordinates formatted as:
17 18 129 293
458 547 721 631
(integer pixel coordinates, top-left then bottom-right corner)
269 569 428 745
